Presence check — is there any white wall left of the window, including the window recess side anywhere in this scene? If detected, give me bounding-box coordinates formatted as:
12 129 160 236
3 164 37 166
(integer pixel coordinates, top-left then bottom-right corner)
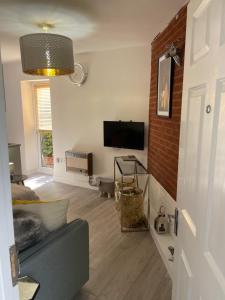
3 62 48 174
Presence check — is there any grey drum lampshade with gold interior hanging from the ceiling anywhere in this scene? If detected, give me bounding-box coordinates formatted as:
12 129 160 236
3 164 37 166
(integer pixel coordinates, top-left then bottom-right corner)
20 33 74 76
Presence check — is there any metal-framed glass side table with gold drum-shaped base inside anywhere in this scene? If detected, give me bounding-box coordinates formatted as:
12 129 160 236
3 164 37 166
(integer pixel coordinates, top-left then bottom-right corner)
114 155 150 232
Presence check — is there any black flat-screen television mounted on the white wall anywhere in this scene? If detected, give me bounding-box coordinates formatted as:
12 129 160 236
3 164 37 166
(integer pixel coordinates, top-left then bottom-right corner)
103 121 145 150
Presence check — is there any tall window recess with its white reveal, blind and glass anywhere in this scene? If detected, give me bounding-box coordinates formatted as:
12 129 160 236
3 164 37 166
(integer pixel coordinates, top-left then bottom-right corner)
21 80 54 175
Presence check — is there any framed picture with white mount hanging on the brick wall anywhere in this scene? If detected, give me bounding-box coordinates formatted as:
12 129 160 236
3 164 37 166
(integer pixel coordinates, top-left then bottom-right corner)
157 55 173 118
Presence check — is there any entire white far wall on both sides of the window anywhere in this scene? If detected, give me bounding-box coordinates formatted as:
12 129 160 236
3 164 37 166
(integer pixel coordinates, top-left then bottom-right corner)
4 47 151 186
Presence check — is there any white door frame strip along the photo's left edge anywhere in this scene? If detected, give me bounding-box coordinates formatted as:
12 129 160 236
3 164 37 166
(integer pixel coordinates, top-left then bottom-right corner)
0 52 19 300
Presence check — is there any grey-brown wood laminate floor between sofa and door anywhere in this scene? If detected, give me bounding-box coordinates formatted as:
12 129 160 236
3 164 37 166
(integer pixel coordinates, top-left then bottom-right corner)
28 176 171 300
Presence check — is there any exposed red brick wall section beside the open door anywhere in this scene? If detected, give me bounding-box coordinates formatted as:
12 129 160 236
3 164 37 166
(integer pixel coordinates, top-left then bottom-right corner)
148 6 187 200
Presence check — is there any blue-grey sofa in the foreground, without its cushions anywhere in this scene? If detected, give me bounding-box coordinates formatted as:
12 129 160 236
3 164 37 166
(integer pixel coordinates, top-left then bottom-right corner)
19 219 89 300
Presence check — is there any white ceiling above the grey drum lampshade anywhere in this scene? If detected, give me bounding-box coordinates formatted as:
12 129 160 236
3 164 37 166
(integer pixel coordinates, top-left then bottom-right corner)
0 0 187 61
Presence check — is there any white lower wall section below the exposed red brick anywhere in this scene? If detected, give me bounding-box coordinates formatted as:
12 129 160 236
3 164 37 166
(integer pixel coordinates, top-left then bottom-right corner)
150 175 176 281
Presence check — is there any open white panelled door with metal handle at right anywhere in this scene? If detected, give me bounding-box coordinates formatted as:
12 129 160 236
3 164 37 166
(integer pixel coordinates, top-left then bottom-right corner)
173 0 225 300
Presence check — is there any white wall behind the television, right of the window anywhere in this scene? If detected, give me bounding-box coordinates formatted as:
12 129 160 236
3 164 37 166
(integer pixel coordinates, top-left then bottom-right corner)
51 47 151 186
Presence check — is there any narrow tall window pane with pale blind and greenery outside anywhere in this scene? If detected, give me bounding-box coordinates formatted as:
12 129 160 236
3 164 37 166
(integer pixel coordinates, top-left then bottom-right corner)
35 84 54 168
